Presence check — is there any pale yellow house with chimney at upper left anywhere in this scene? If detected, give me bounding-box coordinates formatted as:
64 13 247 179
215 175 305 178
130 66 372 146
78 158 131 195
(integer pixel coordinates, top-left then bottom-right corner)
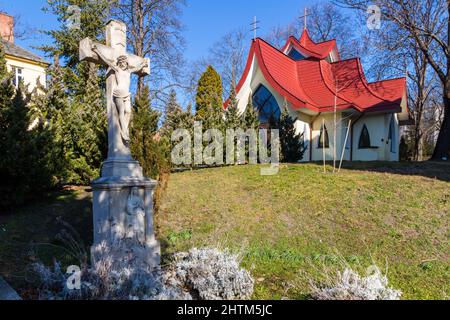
0 12 50 92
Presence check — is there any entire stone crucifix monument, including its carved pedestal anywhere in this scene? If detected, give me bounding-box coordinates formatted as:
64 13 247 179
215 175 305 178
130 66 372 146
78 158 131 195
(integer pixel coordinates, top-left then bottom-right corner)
80 21 160 267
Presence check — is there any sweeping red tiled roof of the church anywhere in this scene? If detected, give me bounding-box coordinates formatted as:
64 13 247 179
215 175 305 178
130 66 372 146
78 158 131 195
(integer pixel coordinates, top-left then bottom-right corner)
232 32 406 112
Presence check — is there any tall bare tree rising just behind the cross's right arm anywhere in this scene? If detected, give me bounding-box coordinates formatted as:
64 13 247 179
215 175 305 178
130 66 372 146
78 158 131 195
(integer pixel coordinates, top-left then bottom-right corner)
114 0 185 101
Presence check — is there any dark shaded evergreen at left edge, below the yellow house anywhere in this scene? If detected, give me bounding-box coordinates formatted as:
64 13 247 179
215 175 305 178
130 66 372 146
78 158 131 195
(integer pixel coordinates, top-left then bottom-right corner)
0 45 59 208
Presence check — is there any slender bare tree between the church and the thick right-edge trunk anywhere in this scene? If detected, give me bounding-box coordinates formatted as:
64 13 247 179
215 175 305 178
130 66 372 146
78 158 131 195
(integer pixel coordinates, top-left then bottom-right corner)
363 8 440 161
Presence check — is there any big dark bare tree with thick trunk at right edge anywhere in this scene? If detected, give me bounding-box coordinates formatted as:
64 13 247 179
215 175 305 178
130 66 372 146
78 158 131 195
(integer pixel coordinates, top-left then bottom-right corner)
335 0 450 160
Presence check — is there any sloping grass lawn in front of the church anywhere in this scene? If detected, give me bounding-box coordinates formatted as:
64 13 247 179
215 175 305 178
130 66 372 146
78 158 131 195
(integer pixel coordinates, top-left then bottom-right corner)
0 163 450 299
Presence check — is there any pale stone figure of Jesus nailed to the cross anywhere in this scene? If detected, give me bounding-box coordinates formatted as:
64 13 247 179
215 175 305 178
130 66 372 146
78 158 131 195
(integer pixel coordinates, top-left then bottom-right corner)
92 44 148 146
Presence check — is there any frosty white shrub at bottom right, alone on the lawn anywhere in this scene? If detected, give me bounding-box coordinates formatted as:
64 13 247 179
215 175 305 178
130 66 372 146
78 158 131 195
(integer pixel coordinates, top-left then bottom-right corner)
311 267 402 300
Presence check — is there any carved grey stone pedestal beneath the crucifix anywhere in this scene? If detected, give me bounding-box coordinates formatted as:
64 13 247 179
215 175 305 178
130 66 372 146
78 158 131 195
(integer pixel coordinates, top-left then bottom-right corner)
92 161 161 268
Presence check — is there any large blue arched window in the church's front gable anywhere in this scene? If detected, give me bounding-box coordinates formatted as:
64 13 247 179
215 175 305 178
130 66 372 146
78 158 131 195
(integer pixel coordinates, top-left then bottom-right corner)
253 85 281 124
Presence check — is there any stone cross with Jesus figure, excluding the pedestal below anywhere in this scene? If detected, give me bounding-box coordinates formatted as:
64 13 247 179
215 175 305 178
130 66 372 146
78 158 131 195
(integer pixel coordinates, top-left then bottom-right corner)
80 20 150 161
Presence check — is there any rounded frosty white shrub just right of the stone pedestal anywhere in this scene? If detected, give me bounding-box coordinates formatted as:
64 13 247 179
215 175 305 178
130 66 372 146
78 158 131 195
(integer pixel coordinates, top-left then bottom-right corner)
168 249 254 300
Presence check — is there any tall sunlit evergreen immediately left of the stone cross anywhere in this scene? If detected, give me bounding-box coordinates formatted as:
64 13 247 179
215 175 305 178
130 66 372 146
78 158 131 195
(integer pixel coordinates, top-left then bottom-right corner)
41 0 113 183
